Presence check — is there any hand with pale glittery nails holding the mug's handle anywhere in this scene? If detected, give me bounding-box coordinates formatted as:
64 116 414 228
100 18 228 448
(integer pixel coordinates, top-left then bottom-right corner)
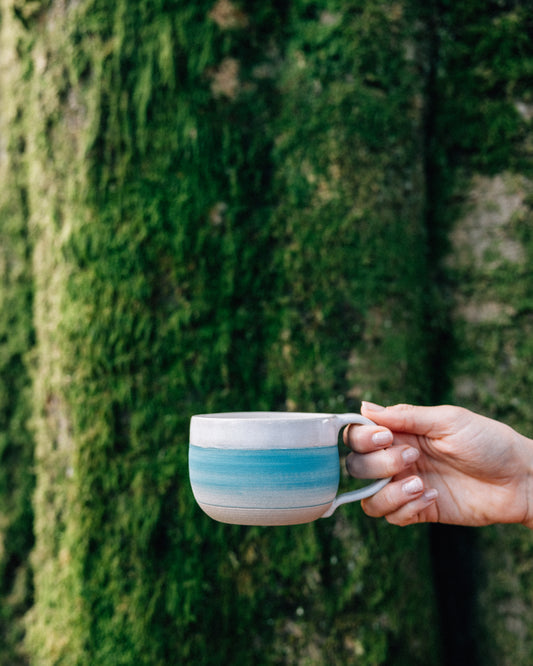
344 402 533 528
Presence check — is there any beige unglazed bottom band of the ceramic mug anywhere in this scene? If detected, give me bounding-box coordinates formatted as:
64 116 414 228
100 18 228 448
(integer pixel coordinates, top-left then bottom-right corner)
198 502 333 527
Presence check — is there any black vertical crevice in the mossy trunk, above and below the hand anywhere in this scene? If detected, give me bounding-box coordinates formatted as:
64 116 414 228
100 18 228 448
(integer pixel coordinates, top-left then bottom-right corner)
424 0 481 666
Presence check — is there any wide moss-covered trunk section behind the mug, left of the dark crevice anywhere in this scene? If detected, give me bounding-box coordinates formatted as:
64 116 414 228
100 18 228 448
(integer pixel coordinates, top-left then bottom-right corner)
11 2 435 665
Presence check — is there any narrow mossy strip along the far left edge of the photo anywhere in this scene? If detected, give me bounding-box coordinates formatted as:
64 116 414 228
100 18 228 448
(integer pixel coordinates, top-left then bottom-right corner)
0 5 34 666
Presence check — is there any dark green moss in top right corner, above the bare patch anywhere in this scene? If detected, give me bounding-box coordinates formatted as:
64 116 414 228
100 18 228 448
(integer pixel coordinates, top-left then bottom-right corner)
437 0 533 173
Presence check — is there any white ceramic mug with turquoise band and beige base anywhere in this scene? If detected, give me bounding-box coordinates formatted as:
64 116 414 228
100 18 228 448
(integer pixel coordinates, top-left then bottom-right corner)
189 412 390 525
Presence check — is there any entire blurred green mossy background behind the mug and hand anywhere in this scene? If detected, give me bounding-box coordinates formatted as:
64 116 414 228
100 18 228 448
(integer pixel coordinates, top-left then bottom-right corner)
0 0 533 666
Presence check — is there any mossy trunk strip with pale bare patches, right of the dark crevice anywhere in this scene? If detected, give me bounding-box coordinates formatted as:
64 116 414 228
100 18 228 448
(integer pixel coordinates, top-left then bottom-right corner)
433 2 533 666
